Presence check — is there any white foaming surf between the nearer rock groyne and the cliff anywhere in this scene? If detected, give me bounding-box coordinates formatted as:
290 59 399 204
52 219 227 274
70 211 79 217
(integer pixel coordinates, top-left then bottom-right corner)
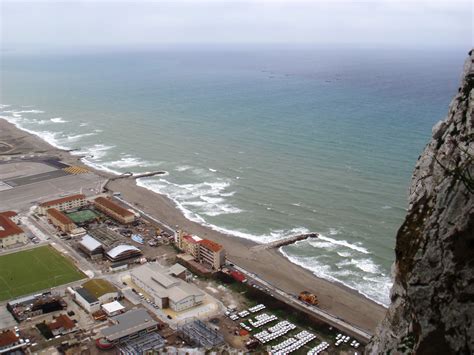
279 248 392 306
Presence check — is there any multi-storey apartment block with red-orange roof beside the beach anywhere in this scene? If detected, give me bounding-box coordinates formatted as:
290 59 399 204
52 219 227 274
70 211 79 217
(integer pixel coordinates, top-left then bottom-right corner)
175 231 225 270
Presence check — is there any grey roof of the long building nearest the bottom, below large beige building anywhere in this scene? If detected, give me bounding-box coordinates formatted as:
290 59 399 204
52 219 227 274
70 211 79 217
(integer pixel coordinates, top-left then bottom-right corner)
102 308 158 341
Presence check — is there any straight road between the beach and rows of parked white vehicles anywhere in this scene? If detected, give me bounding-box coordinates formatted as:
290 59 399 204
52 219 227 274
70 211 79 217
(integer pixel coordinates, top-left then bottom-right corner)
234 264 372 343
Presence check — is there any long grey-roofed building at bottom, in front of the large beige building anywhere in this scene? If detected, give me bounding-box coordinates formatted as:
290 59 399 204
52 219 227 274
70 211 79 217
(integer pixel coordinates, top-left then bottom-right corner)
101 308 159 344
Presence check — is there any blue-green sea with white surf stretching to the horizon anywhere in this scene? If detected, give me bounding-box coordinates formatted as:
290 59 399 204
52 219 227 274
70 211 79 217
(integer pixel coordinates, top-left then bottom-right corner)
0 48 465 304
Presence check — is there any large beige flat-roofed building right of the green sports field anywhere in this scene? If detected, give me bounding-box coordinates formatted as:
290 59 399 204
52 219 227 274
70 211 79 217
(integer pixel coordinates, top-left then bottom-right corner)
131 263 204 312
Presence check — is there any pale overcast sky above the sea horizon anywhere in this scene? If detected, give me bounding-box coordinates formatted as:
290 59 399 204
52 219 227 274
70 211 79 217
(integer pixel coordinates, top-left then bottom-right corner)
0 0 473 51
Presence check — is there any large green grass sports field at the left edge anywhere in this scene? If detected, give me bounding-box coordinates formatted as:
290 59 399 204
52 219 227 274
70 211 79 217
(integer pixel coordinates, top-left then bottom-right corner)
0 246 86 301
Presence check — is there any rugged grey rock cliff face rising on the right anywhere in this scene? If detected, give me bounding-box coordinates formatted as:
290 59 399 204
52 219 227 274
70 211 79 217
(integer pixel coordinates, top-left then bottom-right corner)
367 51 474 354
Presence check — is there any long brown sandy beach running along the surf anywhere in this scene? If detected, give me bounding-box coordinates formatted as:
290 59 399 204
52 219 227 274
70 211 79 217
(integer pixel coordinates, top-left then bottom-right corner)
0 119 386 333
